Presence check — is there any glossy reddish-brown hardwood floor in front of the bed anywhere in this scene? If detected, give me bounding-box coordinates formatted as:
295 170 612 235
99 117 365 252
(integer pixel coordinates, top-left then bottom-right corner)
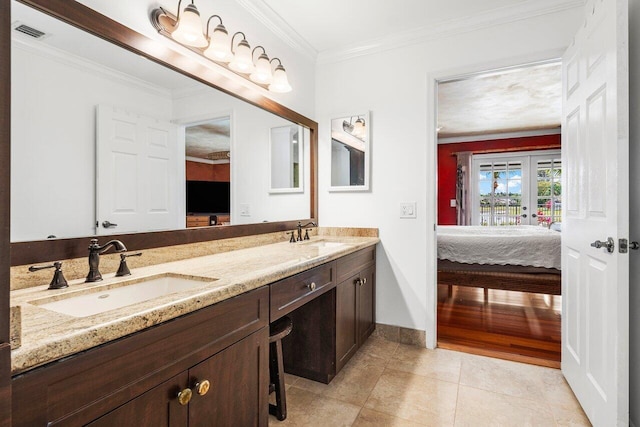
438 285 562 367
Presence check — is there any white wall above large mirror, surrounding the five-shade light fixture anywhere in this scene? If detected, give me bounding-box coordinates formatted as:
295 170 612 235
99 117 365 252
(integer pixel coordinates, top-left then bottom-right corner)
78 0 315 117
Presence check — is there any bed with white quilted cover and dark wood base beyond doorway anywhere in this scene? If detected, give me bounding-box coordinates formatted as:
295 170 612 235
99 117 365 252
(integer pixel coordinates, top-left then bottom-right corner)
437 226 561 295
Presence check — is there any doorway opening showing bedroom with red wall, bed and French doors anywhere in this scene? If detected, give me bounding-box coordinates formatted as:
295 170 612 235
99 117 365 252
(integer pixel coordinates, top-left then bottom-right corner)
437 61 562 367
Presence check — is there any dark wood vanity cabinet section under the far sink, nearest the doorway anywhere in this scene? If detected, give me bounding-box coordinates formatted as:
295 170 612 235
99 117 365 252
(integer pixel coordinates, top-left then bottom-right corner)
336 248 376 371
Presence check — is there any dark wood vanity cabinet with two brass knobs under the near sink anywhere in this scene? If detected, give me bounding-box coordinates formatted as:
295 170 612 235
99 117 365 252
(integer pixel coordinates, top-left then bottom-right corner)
12 287 269 427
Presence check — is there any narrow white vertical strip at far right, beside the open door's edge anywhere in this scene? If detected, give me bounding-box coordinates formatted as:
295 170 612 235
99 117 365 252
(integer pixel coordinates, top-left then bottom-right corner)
629 0 640 426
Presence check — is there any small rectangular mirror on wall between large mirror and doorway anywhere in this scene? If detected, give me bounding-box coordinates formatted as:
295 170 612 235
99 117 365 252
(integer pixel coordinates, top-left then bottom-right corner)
329 113 370 191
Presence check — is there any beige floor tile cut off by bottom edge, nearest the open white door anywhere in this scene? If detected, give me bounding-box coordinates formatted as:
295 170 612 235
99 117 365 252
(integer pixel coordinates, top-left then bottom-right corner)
455 385 555 427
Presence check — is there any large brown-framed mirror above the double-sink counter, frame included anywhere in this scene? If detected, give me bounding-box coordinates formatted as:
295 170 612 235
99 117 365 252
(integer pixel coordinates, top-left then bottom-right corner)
5 0 317 265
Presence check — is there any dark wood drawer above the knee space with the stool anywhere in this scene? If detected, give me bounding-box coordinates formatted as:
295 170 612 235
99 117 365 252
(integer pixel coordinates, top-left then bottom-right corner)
269 262 335 322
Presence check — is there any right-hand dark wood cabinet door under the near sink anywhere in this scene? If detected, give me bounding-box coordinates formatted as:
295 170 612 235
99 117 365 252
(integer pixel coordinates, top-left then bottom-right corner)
189 328 269 427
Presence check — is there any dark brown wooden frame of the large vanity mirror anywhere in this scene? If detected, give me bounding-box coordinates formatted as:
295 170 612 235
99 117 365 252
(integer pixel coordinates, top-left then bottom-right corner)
8 0 318 266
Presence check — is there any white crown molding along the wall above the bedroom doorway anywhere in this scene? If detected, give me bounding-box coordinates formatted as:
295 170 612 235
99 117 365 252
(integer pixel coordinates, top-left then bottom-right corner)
318 0 586 64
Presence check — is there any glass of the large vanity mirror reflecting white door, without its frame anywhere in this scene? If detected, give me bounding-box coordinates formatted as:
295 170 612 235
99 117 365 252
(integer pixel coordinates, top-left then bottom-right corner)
11 2 311 242
